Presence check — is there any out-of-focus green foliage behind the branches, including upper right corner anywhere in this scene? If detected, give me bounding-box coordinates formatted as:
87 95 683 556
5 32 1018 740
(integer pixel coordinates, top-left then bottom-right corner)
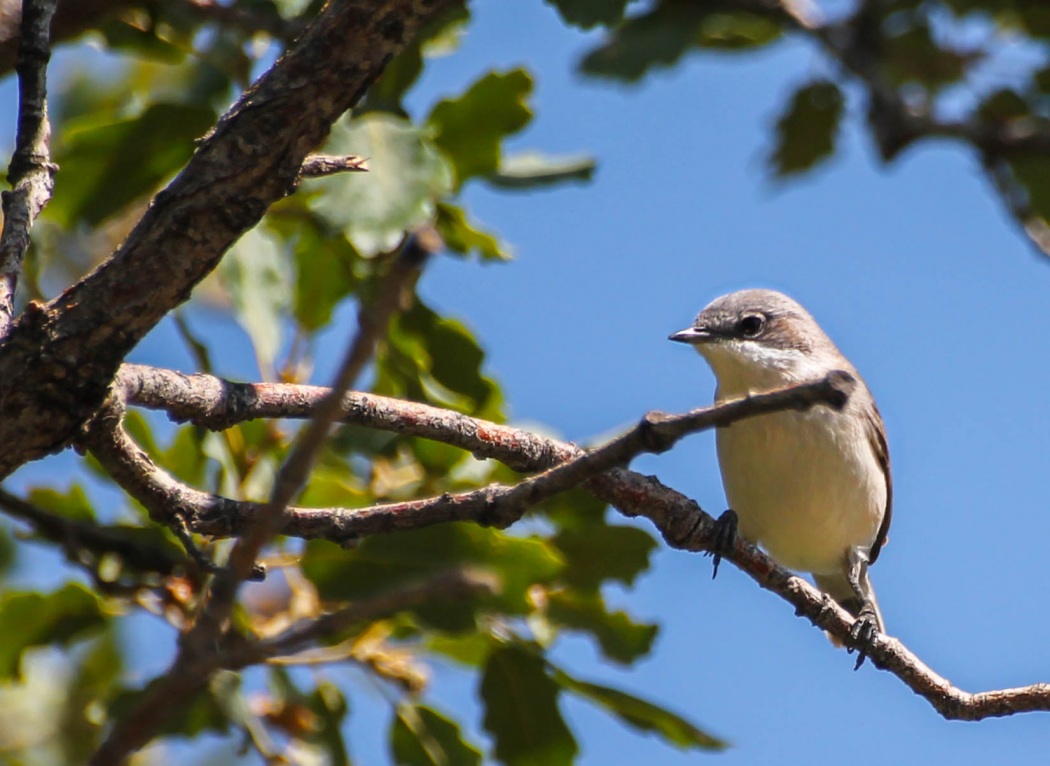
6 0 1050 766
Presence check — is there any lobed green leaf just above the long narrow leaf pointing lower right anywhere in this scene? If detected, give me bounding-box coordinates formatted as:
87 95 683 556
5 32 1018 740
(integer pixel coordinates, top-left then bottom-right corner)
547 590 658 665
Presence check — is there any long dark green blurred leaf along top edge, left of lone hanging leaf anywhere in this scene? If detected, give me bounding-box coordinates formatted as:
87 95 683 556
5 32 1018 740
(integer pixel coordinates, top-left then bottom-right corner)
580 1 780 82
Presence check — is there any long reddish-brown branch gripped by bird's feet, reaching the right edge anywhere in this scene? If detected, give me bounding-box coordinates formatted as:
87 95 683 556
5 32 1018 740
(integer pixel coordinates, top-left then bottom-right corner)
106 365 1050 721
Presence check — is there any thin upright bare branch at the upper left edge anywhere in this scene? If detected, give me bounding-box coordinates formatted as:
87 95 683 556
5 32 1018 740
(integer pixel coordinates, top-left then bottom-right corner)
0 0 58 340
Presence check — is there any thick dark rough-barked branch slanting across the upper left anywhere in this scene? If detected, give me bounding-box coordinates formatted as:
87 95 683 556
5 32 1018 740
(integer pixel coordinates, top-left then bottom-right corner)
0 0 464 480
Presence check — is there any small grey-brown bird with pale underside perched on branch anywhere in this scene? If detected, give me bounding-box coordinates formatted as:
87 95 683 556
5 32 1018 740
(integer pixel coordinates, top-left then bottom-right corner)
670 290 893 646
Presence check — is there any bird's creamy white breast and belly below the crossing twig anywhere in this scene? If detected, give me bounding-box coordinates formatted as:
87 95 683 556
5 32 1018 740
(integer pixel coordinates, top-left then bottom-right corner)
717 407 887 574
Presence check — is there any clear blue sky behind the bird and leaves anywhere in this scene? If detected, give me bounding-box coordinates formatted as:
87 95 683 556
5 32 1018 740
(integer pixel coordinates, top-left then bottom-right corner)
0 0 1050 766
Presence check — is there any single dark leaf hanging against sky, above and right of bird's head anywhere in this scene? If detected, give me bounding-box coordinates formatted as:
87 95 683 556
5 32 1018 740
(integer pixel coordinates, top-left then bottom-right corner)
770 80 844 177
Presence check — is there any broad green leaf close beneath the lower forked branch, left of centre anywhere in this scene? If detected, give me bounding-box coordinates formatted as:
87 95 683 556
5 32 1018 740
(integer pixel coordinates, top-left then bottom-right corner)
302 523 563 630
